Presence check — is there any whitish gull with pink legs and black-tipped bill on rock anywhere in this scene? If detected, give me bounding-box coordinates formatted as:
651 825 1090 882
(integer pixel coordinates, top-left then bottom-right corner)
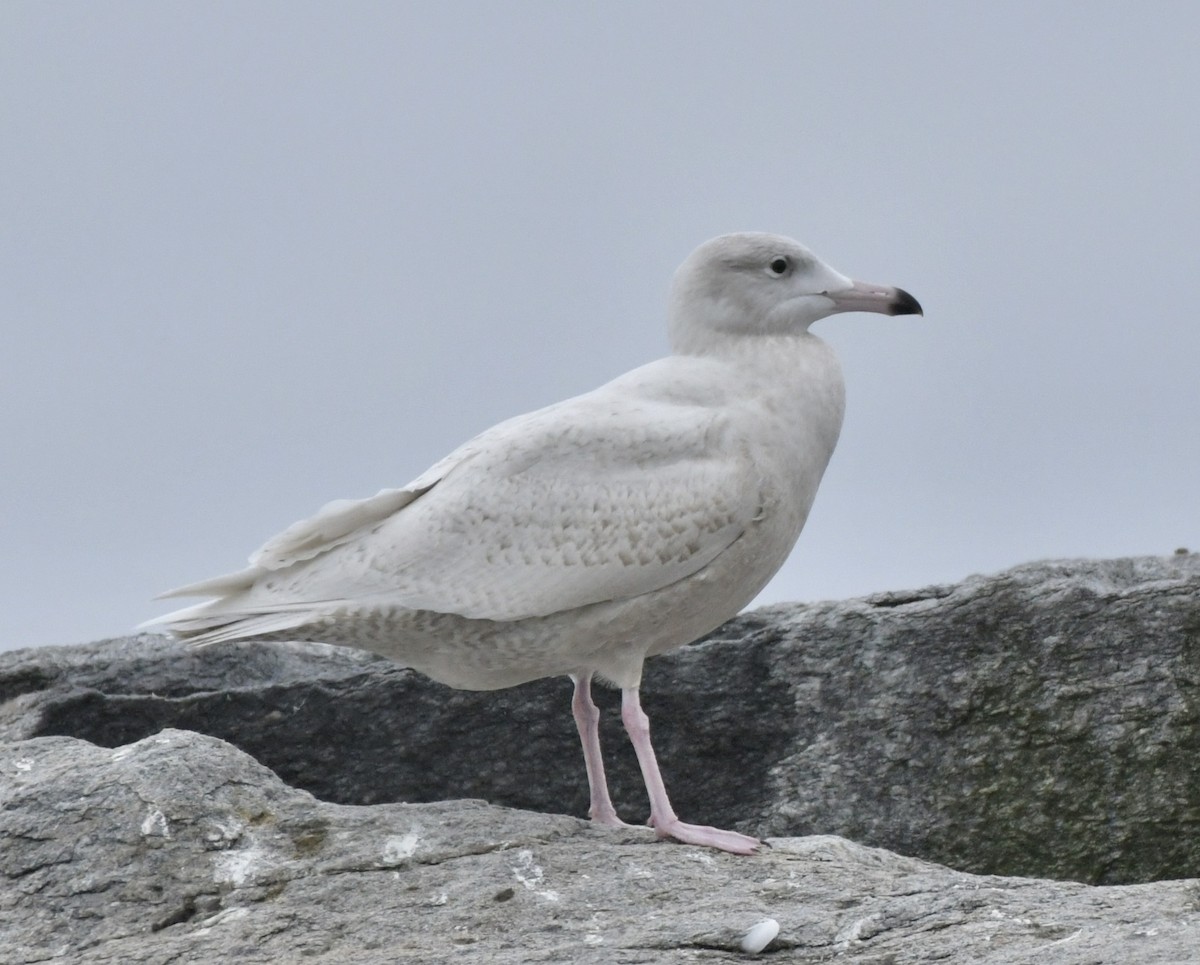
143 233 922 853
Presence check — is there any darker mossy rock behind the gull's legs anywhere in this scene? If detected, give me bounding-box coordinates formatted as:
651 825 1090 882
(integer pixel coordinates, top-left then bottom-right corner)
0 555 1200 883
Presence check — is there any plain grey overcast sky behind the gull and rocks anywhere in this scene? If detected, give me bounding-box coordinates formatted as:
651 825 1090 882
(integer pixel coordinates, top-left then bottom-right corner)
0 0 1200 648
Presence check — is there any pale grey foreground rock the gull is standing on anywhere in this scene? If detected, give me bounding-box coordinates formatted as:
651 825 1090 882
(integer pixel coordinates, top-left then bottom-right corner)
0 730 1200 965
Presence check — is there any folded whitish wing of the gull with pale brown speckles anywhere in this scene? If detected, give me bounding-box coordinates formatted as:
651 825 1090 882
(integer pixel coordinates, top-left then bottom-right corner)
142 372 760 639
